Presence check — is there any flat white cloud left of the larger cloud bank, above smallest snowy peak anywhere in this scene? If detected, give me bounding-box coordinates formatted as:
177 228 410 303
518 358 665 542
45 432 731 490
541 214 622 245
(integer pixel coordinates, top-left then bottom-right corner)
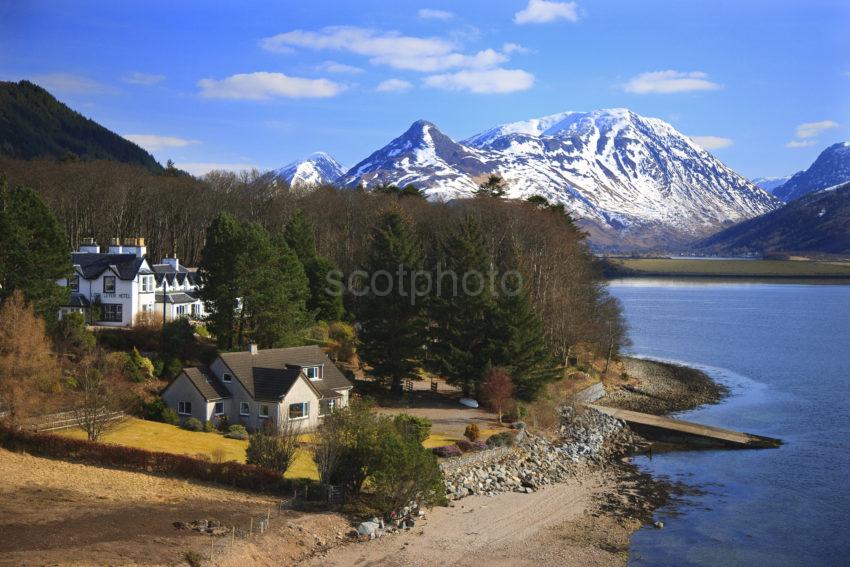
198 72 344 100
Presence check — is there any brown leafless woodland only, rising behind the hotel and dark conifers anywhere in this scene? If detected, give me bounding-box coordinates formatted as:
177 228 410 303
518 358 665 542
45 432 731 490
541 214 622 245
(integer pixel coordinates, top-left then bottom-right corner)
0 159 624 372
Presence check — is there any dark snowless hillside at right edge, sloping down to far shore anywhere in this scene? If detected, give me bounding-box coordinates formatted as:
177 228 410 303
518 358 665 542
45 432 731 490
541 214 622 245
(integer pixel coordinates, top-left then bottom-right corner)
698 183 850 254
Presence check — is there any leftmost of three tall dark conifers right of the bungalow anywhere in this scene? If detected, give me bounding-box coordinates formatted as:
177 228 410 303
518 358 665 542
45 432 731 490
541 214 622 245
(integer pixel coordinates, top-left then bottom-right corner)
358 210 425 391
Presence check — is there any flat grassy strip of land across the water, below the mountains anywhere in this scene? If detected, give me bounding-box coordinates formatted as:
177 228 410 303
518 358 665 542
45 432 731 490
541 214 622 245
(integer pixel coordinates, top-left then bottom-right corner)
607 258 850 278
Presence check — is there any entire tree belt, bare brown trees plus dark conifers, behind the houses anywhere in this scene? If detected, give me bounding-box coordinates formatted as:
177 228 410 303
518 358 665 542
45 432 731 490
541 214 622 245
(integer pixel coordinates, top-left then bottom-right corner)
0 156 625 397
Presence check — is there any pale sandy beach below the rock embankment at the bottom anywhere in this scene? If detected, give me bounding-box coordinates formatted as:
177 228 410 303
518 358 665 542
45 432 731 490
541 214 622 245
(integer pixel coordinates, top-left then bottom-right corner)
307 470 640 567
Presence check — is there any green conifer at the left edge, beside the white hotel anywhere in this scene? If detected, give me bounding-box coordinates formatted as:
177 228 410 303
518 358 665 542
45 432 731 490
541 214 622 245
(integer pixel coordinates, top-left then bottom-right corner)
0 178 72 320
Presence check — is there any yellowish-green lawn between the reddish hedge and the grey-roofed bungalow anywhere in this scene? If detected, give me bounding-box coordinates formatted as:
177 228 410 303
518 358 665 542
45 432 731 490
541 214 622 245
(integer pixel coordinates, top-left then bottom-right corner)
57 417 319 479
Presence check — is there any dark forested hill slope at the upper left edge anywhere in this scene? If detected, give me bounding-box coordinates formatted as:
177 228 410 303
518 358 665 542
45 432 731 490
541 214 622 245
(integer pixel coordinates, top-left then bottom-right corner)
0 81 162 171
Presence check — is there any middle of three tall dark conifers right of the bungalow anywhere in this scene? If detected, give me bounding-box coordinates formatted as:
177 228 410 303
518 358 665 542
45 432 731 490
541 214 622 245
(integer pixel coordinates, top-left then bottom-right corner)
429 217 498 394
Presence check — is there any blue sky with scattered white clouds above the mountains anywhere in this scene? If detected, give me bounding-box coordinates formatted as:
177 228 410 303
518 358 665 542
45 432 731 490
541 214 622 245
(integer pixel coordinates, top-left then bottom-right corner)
0 0 850 177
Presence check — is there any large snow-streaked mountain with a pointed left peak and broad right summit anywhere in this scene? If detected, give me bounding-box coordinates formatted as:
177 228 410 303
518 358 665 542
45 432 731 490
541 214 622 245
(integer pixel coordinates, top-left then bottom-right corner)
340 109 780 246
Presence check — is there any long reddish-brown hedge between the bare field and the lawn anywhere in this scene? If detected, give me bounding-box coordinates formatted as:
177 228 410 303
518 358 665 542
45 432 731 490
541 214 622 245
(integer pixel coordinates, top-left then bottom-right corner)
0 428 294 492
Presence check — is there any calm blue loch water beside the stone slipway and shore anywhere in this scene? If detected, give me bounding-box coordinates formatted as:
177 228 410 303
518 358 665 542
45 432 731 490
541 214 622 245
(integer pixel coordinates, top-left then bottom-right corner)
611 279 850 566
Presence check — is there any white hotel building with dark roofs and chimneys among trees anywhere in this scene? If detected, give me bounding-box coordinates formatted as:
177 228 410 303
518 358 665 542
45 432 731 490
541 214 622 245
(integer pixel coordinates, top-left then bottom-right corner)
58 238 205 327
